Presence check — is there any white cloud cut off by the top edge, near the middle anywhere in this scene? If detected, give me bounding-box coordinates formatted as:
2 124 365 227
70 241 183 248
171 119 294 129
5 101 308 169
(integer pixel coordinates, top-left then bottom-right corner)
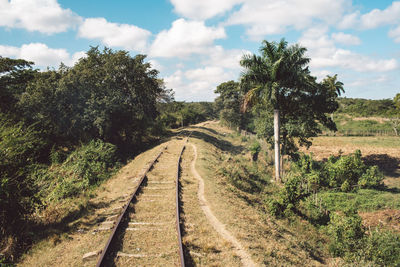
171 0 243 20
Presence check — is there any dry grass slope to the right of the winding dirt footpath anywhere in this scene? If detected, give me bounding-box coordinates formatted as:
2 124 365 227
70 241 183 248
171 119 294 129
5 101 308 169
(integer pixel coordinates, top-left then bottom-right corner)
191 123 328 266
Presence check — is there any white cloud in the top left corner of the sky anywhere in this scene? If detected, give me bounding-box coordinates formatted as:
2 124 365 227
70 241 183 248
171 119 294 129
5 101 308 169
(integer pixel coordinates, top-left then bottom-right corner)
0 0 82 34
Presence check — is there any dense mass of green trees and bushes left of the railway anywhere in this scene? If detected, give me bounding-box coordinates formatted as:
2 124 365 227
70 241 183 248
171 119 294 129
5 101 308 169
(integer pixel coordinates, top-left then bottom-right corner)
0 47 214 260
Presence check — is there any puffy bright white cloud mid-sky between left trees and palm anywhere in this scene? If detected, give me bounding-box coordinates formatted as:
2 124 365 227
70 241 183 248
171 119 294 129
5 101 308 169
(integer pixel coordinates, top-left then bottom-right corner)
150 19 226 58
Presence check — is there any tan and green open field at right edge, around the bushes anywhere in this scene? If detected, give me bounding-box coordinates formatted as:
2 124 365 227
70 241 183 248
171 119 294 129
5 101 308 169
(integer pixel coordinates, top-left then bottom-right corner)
302 136 400 231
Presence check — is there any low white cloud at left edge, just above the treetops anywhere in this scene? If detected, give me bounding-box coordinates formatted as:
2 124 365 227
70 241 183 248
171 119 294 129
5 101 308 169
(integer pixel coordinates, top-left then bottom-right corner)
0 43 85 67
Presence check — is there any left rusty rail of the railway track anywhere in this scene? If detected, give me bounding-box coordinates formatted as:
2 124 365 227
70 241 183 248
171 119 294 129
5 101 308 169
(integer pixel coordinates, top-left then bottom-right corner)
96 146 167 267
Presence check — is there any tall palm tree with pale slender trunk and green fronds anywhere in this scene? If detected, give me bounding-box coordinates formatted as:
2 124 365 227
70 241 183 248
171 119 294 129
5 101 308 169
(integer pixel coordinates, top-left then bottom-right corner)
240 39 313 181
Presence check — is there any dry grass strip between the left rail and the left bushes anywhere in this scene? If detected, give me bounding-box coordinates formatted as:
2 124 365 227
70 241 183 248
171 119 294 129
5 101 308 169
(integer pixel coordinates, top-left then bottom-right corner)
18 140 173 266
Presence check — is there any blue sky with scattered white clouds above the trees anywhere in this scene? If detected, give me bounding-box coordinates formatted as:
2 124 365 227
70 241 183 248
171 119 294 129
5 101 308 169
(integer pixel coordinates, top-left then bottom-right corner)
0 0 400 102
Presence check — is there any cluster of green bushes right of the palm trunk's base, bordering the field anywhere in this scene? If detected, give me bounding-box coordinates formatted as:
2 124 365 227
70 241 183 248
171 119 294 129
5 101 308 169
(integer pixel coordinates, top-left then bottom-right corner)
269 151 383 219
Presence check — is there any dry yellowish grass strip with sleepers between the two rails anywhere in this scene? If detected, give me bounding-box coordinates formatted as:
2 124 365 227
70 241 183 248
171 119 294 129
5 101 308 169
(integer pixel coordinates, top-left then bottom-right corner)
115 141 183 266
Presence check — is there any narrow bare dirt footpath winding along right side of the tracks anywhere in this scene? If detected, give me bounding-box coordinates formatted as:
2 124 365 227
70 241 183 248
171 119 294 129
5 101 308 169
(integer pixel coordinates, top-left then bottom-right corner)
191 144 256 266
